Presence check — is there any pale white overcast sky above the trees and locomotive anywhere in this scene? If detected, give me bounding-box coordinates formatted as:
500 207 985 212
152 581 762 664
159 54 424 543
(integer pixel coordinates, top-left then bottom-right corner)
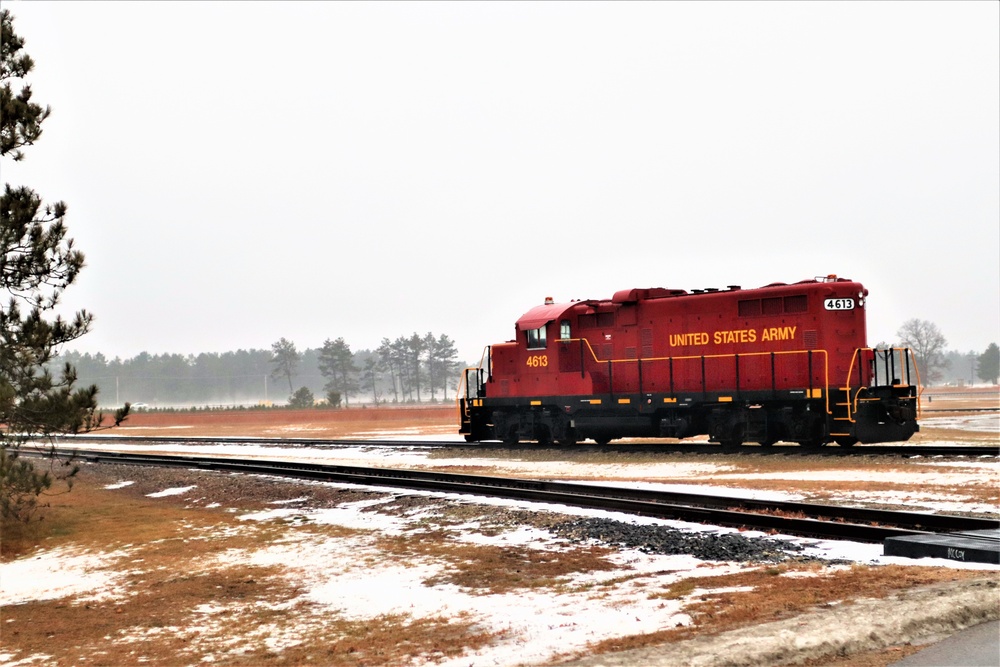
3 2 1000 361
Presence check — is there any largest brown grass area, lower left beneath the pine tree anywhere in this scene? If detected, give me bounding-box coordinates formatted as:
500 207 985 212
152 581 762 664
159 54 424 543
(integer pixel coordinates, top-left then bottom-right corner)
0 467 508 666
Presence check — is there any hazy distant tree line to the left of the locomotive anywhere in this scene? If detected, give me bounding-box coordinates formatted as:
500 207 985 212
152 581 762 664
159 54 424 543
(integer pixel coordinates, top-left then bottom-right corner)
54 332 462 408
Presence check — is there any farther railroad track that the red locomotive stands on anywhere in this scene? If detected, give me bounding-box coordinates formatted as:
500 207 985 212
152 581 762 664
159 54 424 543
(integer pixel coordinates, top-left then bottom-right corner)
59 435 1000 457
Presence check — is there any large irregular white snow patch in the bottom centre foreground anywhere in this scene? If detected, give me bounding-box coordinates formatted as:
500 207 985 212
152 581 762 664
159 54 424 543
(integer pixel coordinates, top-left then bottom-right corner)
219 516 741 667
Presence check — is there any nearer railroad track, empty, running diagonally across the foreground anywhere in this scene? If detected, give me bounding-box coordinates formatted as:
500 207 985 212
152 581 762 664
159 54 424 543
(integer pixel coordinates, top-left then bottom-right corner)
37 450 1000 542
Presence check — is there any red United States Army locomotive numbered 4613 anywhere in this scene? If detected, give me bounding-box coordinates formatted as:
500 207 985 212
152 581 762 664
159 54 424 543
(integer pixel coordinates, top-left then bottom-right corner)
458 275 919 446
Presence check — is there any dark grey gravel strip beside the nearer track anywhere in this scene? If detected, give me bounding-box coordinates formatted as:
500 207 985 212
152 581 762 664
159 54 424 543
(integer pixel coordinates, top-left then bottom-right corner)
549 518 803 563
